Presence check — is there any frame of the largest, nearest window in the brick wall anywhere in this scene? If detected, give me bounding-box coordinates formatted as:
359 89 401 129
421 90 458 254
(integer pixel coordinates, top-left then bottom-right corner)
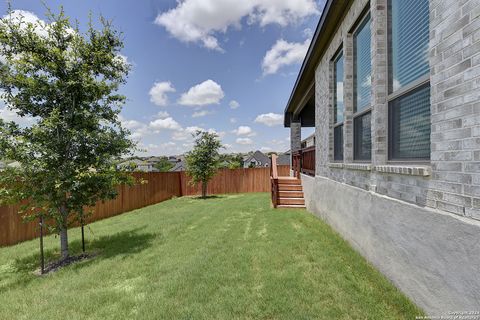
385 0 432 165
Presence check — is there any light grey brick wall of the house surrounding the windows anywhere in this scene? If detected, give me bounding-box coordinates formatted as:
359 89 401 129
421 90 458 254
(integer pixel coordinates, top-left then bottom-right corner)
315 0 480 219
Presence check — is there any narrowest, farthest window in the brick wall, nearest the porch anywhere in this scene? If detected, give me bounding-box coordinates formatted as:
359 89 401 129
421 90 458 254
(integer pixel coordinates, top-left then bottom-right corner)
333 51 344 161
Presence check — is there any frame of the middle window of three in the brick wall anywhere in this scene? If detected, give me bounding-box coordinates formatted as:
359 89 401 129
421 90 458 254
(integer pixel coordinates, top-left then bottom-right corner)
350 12 373 163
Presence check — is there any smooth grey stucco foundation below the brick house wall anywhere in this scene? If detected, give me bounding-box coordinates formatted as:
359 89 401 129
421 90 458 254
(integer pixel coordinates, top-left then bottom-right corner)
302 175 480 315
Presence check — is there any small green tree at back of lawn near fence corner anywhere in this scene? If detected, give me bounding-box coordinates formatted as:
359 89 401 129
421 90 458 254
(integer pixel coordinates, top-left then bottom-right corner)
185 131 222 198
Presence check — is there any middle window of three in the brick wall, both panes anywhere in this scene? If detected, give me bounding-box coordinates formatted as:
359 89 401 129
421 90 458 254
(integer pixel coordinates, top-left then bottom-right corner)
353 14 372 161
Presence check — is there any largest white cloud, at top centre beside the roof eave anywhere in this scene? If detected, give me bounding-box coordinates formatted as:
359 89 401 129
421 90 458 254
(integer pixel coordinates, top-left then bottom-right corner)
155 0 319 51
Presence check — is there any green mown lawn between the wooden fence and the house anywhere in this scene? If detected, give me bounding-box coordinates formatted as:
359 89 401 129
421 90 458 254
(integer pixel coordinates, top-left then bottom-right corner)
0 194 423 319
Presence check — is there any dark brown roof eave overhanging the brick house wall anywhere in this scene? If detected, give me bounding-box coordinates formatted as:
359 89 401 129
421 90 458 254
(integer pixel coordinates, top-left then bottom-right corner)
284 0 353 127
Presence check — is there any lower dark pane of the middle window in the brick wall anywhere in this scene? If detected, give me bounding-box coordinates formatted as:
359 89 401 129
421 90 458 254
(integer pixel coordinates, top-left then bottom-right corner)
353 112 372 160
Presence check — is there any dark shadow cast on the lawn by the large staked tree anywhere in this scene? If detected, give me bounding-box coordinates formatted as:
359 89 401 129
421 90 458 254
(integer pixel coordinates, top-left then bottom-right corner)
0 228 155 292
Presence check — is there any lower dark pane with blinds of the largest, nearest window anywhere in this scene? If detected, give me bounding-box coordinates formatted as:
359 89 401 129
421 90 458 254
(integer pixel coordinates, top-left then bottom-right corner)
389 84 430 160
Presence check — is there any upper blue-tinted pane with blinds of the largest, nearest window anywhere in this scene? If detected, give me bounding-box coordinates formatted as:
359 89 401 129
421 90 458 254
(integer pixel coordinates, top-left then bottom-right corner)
389 0 430 92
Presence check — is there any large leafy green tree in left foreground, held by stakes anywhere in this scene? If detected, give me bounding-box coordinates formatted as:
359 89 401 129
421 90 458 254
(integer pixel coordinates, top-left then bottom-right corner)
0 8 135 260
